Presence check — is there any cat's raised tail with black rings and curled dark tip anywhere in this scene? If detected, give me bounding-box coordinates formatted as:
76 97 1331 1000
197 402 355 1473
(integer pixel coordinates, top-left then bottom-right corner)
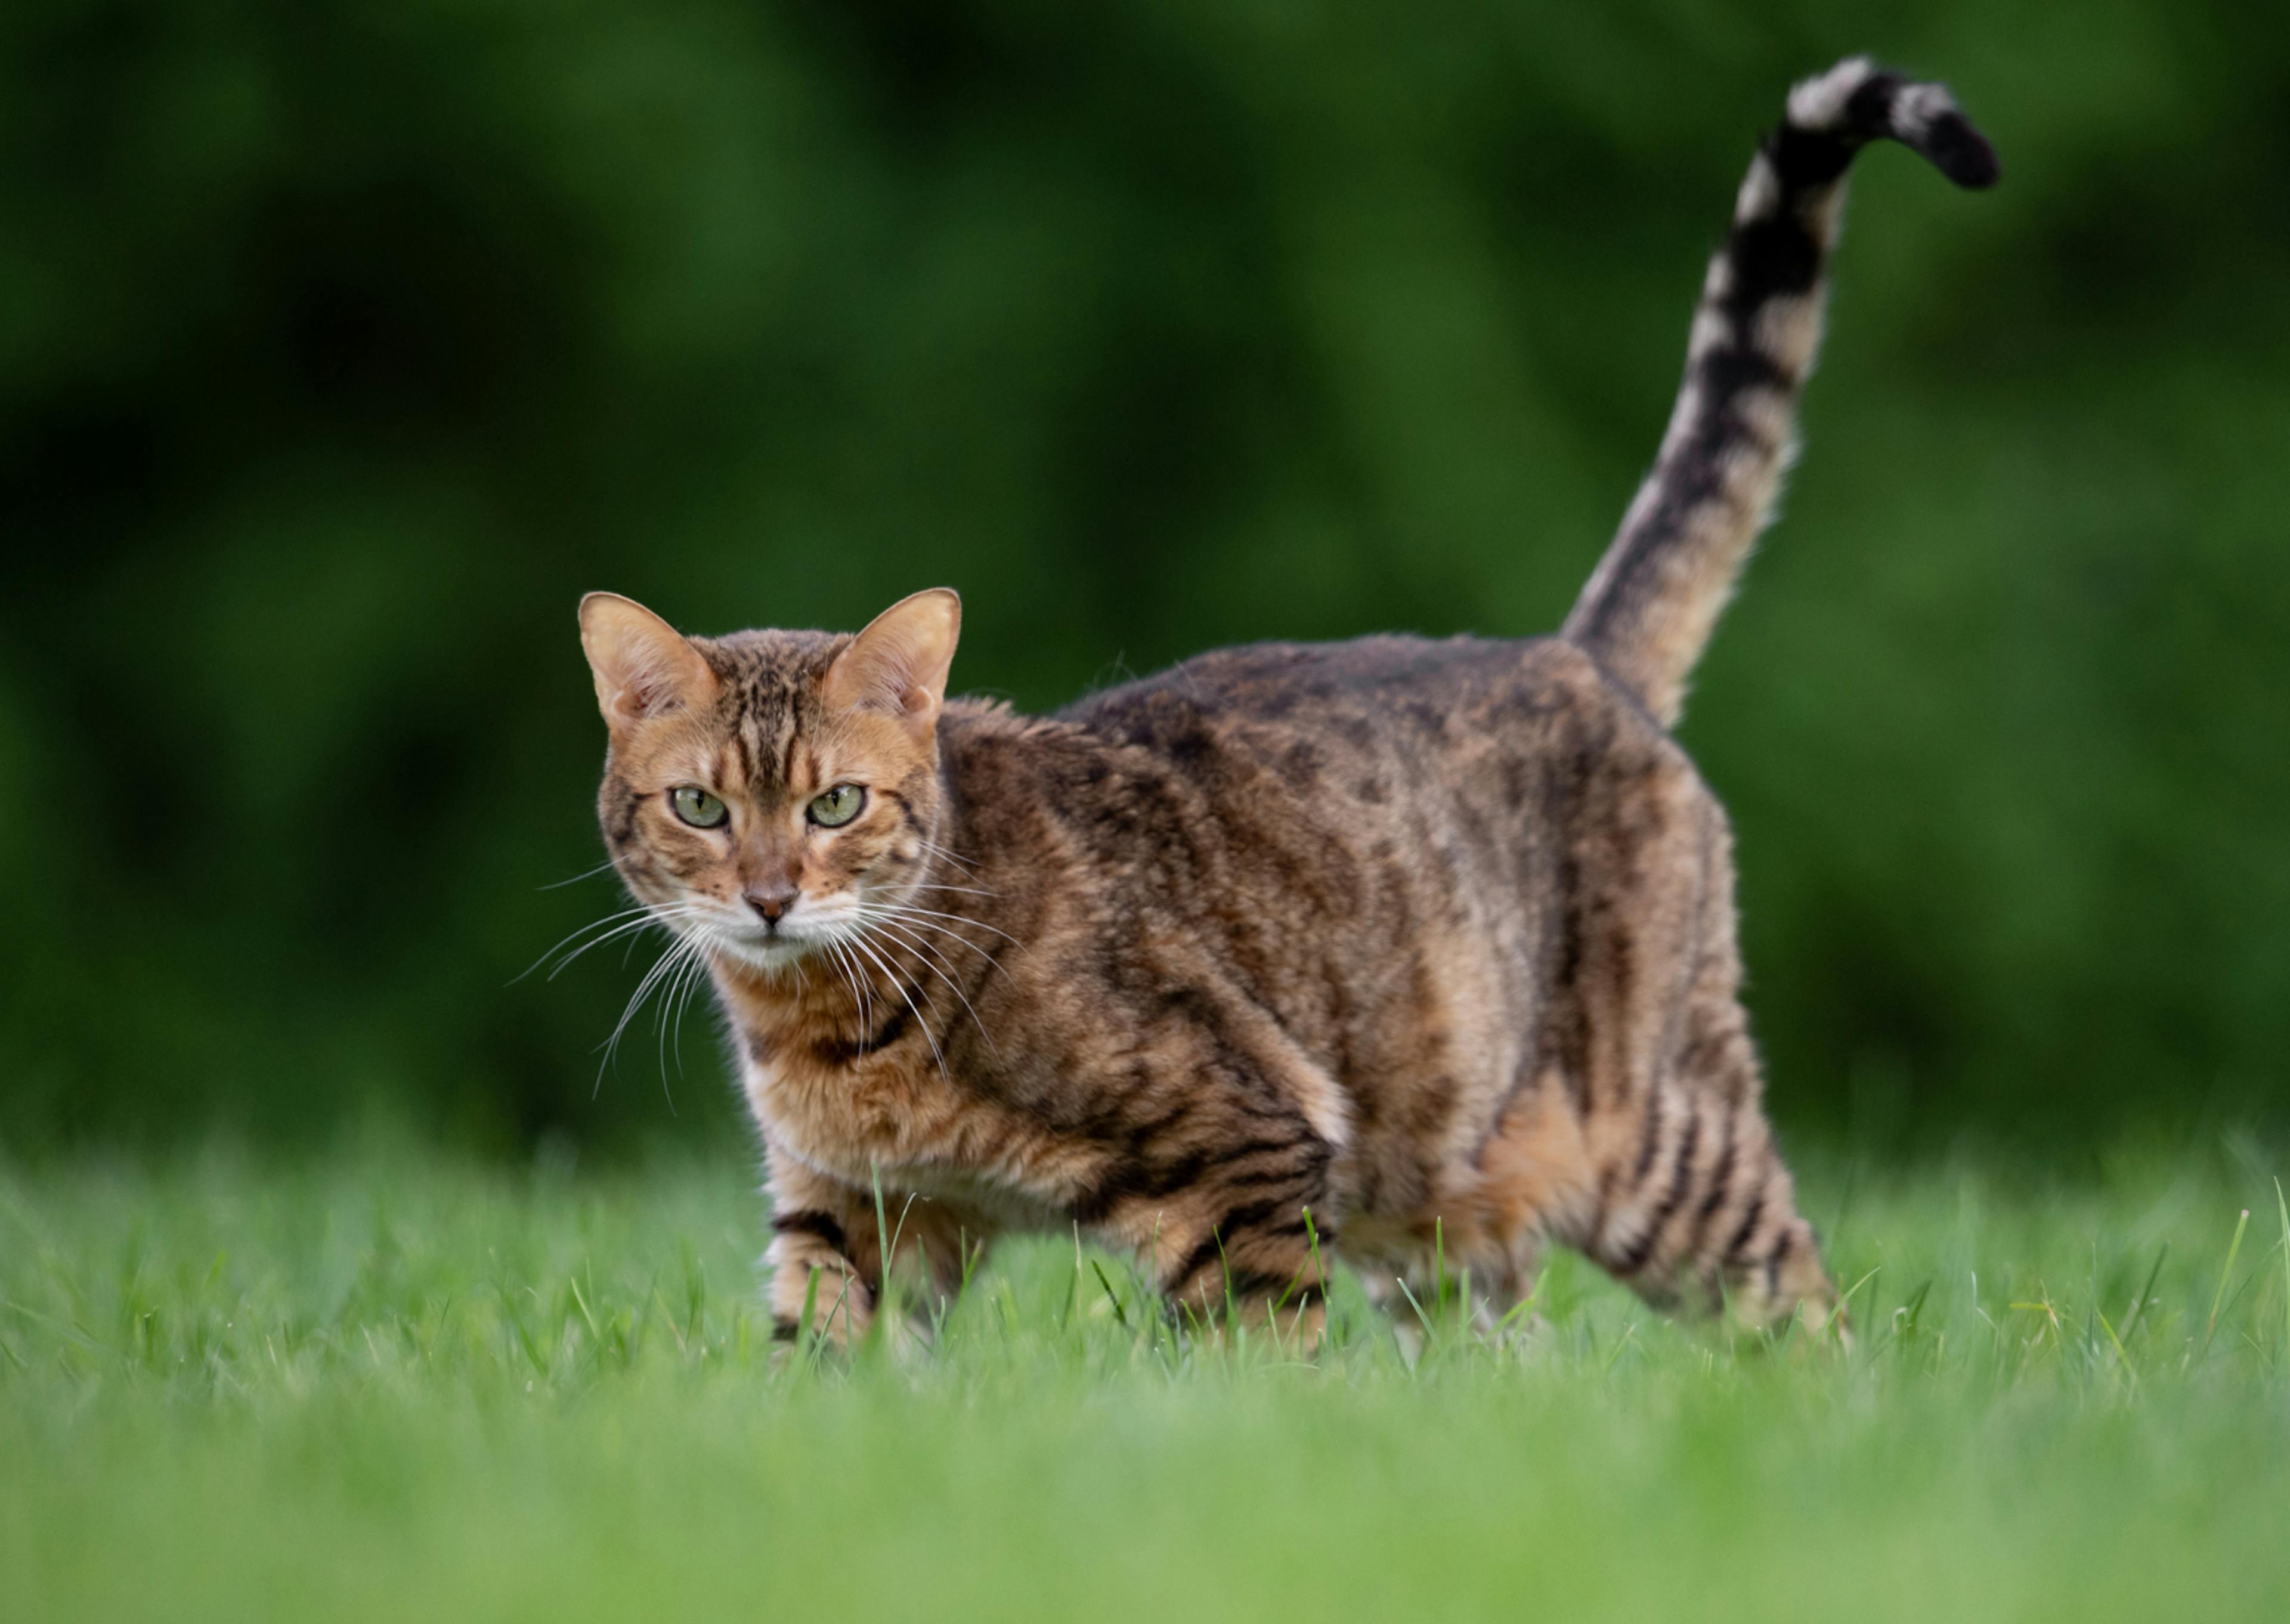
1564 57 1997 726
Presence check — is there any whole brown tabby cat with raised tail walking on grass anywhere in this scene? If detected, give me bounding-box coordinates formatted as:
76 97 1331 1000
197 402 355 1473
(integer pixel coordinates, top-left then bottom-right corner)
581 60 1997 1338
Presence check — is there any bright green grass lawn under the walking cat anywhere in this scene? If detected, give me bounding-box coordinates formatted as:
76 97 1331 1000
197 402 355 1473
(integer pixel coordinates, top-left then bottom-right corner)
0 1148 2290 1619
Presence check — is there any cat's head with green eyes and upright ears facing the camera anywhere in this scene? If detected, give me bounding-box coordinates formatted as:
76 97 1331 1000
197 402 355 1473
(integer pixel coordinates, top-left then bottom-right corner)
580 588 962 971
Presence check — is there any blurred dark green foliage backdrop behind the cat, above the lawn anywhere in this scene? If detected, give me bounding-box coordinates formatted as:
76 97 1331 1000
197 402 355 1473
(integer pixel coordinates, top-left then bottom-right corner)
0 0 2290 1152
